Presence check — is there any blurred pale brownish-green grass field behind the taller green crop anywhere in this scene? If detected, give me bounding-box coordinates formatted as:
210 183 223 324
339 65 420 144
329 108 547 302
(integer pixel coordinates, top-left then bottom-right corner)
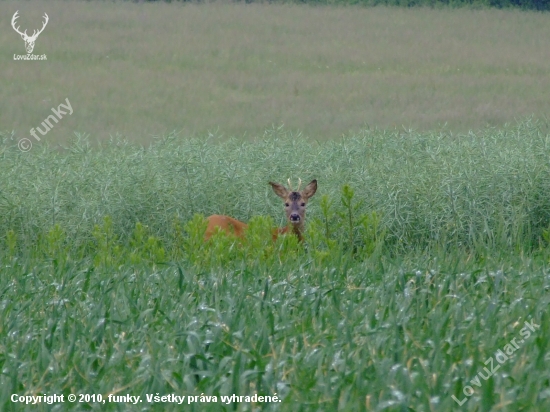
0 1 550 143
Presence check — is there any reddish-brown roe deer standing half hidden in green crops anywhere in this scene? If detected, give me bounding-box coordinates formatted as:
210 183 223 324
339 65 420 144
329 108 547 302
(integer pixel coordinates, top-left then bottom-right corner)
204 179 317 242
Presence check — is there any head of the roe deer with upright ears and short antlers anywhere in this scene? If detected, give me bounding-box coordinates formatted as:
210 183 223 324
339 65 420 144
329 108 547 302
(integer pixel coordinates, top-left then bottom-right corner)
269 179 317 234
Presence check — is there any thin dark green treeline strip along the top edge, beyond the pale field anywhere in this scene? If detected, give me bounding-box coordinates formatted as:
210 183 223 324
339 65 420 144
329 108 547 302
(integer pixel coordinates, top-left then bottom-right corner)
151 0 550 11
